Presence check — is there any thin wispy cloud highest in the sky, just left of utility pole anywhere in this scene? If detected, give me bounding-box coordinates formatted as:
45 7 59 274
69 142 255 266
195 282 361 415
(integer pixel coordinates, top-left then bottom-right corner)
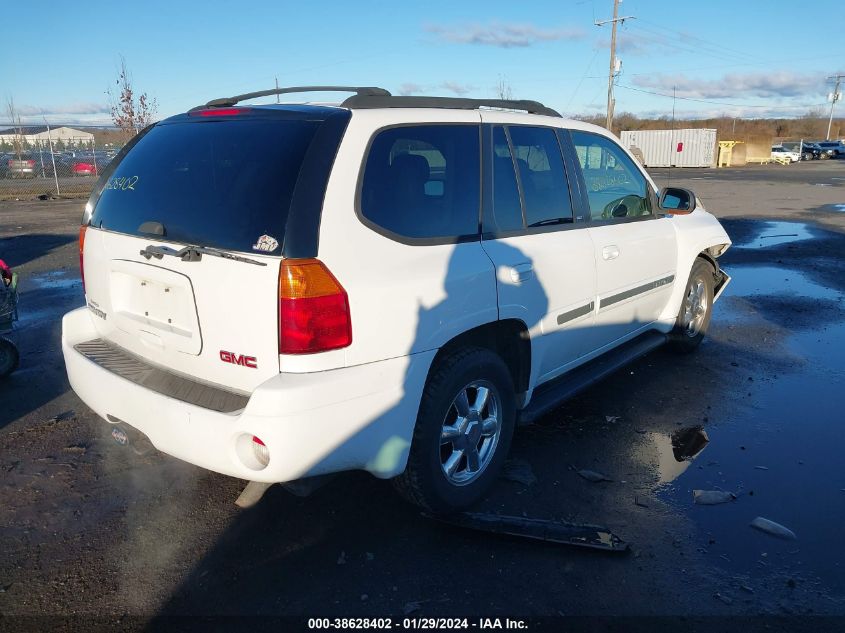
425 22 584 48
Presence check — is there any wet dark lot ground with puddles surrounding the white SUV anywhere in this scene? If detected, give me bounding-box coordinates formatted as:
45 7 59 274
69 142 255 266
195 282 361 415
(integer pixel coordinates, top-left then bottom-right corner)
0 161 845 631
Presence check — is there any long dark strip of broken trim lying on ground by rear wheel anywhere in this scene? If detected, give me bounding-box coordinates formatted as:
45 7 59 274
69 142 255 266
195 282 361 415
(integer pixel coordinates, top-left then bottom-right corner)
423 512 628 552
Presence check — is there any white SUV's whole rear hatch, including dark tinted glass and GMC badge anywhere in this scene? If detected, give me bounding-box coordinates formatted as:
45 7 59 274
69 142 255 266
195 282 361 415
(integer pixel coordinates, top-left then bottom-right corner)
83 107 349 393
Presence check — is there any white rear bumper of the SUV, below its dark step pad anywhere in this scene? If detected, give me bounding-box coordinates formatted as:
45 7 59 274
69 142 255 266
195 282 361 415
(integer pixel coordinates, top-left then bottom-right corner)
62 308 435 482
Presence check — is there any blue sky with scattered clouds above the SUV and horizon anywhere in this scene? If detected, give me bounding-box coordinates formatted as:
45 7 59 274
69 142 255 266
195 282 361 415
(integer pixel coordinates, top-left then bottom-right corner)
0 0 845 123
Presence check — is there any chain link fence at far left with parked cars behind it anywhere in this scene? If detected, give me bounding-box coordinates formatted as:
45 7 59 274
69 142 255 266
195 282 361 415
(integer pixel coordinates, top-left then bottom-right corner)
0 125 125 200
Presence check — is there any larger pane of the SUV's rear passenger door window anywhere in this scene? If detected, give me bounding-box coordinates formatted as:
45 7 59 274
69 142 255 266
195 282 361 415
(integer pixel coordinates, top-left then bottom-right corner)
508 125 573 228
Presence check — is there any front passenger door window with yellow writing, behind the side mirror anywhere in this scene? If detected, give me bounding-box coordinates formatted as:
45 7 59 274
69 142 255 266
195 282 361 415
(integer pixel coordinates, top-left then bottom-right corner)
571 130 651 220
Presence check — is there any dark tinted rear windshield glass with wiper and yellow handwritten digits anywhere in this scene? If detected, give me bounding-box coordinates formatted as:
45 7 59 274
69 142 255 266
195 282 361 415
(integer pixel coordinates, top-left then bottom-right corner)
91 118 320 254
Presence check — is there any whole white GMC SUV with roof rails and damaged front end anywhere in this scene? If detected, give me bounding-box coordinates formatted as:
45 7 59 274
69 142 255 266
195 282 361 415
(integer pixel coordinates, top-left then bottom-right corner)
62 87 730 512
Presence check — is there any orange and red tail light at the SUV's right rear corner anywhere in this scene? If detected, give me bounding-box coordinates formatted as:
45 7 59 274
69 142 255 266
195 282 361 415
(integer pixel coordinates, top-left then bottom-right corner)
279 259 352 354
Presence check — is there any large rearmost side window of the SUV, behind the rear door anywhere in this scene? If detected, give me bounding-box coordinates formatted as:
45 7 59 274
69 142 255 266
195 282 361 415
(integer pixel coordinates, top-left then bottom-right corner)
360 125 481 240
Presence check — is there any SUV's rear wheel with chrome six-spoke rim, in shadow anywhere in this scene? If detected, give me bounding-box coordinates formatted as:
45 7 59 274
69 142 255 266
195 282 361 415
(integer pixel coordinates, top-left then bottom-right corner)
394 348 516 514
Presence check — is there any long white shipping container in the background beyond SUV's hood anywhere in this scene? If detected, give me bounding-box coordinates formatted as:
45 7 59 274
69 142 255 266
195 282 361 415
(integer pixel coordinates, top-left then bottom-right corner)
622 129 716 167
